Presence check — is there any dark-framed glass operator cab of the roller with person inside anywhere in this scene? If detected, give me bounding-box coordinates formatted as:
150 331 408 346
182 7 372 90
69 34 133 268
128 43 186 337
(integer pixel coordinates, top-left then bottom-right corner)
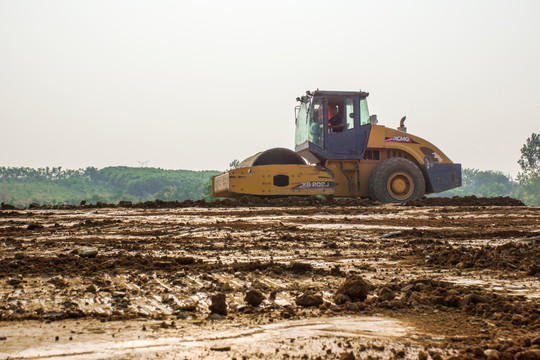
295 90 371 164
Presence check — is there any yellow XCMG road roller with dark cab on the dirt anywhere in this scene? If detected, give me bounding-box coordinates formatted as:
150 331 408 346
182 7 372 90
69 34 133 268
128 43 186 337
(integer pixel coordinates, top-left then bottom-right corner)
212 89 461 203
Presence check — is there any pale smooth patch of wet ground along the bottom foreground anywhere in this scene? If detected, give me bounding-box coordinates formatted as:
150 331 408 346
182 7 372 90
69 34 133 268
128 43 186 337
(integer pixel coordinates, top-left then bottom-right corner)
0 317 414 359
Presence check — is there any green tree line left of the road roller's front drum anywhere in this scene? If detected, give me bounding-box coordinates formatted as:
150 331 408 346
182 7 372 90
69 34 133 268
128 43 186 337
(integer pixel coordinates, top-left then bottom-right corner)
0 166 219 207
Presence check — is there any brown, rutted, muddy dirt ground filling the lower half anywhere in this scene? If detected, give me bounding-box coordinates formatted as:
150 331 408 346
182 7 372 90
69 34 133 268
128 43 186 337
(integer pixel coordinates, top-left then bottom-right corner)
0 197 540 359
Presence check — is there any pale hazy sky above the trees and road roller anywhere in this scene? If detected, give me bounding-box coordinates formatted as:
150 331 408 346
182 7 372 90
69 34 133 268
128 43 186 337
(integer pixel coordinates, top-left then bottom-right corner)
0 0 540 175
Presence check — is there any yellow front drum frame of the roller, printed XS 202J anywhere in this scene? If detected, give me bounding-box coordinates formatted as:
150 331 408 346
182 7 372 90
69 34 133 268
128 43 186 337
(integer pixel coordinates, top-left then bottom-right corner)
212 165 334 197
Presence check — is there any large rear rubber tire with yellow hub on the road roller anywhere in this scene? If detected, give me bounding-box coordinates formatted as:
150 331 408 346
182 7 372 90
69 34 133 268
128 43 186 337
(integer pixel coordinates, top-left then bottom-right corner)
369 158 426 203
